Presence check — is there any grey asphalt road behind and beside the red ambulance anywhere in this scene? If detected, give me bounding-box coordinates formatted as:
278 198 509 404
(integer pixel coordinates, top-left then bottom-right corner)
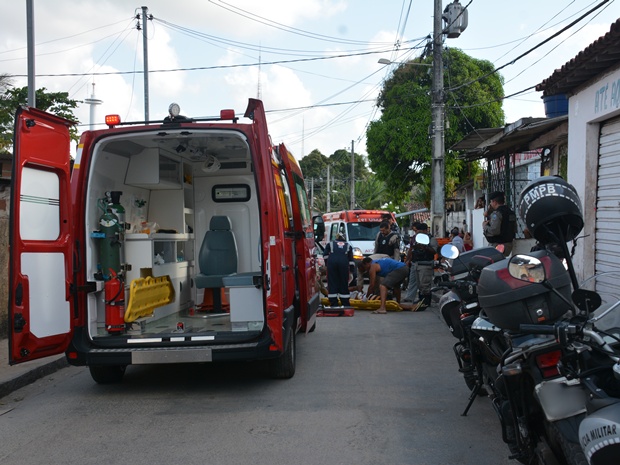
0 308 516 465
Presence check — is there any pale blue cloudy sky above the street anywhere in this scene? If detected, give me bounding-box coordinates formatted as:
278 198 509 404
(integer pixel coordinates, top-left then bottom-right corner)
0 0 620 158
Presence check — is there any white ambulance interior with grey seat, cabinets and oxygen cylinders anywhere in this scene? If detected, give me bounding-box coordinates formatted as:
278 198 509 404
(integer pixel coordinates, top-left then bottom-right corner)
86 129 264 341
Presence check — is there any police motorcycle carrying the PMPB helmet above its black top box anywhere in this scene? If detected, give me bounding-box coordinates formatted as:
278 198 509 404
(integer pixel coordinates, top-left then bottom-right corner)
470 176 587 465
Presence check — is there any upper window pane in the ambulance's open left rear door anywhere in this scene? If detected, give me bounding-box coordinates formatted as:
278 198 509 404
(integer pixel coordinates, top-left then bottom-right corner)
19 168 60 241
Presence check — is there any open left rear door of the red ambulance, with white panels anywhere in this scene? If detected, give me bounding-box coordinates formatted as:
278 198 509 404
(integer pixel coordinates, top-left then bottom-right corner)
9 108 74 364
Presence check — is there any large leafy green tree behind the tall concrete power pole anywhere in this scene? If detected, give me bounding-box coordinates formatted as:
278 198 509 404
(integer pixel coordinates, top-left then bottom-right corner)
366 48 504 205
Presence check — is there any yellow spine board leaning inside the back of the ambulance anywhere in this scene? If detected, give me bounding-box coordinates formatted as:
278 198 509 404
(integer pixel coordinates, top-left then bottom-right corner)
125 276 174 323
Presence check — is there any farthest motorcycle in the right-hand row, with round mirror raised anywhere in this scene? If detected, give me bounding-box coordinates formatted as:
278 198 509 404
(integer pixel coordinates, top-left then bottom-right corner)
433 244 505 395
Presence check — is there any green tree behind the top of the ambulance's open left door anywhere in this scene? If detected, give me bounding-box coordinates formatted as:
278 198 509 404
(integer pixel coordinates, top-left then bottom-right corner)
0 84 80 152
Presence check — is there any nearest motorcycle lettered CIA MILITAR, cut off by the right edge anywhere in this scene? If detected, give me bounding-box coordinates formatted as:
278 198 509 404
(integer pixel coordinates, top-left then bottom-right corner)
505 255 620 465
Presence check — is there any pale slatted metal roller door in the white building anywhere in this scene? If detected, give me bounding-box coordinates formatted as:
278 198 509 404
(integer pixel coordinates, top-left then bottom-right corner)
595 118 620 273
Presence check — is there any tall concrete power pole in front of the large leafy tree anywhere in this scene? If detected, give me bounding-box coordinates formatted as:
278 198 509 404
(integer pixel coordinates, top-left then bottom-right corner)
431 0 446 237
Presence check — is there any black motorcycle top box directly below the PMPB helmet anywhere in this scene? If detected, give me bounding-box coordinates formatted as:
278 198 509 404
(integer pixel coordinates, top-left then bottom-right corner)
478 250 571 331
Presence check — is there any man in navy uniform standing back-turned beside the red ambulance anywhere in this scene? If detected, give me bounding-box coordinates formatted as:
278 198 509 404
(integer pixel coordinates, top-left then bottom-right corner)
323 233 355 307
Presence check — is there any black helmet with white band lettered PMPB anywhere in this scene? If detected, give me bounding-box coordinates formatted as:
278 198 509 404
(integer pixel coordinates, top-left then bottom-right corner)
519 176 583 243
